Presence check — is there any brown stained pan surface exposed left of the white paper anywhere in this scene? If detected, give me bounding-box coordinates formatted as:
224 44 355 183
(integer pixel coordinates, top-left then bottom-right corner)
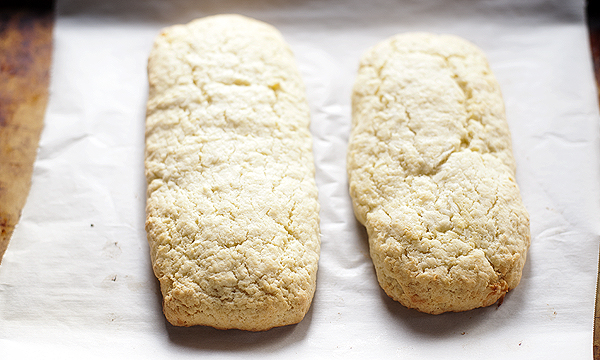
0 6 54 261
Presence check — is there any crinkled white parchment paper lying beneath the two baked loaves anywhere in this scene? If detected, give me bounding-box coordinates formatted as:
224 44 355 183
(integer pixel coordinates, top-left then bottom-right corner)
0 0 600 359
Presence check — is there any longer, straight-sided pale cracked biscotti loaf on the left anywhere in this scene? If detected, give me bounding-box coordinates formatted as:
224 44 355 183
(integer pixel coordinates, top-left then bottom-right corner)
145 15 320 331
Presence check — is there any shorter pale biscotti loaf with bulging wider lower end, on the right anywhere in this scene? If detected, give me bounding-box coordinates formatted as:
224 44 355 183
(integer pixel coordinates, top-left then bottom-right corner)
348 33 530 314
